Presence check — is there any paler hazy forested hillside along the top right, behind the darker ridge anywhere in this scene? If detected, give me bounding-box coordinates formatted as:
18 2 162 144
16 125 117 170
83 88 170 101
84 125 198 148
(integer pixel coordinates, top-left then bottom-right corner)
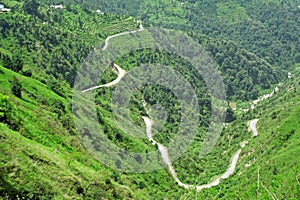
56 0 300 69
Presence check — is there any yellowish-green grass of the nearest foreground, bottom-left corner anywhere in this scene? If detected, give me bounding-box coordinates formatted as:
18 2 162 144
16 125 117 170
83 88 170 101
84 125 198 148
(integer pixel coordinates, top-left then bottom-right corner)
0 124 134 199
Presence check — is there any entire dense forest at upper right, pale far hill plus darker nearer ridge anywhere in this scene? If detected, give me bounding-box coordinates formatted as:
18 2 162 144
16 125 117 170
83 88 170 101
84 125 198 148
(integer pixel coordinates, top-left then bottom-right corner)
48 0 300 100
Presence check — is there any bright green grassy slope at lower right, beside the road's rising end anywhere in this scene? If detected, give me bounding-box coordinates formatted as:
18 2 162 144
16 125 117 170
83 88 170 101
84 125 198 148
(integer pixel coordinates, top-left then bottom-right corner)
200 74 300 199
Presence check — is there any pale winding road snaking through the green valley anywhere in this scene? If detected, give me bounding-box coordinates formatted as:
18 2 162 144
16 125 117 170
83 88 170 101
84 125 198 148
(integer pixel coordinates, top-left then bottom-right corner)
82 23 258 192
